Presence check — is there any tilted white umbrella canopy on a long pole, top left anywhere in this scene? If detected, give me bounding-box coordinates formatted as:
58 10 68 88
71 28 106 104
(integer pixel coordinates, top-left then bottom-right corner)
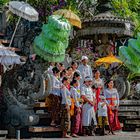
9 1 38 21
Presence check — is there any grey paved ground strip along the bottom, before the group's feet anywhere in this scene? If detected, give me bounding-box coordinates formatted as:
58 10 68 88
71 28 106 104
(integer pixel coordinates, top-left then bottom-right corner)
6 132 140 140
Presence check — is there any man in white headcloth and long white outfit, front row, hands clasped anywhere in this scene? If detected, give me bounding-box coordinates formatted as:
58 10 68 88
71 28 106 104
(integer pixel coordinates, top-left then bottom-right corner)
81 77 97 135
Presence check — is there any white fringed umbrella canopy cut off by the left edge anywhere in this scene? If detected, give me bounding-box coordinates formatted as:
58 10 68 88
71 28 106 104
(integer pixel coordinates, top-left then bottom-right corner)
0 45 22 66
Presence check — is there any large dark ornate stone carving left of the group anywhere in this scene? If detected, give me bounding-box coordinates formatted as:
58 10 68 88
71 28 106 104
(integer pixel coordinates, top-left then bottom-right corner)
2 60 49 128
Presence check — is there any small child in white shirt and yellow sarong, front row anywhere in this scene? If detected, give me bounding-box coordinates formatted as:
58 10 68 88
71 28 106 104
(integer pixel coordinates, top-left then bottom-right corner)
98 96 109 136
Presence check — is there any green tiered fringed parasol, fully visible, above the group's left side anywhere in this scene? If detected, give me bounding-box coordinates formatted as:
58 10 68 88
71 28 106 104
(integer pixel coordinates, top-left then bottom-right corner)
34 15 71 62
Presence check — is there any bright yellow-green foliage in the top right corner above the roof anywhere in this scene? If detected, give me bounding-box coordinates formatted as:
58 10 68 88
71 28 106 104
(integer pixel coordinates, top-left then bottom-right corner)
112 0 140 34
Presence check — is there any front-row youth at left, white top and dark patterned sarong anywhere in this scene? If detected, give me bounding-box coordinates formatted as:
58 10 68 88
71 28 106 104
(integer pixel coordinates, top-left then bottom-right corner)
61 77 71 138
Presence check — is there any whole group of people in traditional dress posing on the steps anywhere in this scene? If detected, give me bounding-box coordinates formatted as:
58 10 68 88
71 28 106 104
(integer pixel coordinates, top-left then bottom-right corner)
46 56 121 138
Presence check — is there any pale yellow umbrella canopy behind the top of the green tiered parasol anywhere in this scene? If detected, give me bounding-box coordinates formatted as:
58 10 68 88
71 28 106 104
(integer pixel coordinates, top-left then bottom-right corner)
53 9 81 28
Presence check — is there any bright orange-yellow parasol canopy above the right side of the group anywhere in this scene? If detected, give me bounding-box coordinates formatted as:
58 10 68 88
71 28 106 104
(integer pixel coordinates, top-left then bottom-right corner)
95 54 123 67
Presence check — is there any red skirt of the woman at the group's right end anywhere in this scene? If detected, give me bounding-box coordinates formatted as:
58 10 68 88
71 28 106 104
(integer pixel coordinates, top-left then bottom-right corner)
108 106 121 131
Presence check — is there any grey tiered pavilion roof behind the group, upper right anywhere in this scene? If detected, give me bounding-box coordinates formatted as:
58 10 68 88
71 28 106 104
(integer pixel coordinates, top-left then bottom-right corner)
77 12 134 38
